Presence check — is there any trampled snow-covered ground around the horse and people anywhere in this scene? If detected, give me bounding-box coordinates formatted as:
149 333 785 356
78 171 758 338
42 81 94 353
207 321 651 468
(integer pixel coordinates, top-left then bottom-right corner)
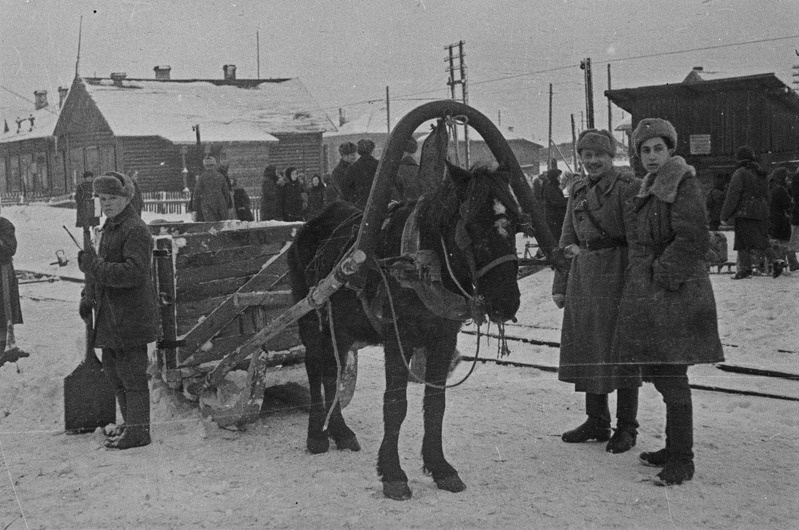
0 201 799 529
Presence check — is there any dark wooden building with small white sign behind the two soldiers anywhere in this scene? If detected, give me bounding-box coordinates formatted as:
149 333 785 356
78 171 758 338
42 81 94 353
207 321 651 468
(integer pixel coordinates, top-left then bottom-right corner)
605 67 799 187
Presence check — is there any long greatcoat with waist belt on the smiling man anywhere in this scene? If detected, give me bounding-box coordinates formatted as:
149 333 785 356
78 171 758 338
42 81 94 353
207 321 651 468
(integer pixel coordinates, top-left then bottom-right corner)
552 168 641 394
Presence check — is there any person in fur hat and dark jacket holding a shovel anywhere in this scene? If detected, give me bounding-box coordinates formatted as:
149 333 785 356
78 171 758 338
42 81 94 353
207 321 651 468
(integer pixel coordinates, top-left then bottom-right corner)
78 171 158 449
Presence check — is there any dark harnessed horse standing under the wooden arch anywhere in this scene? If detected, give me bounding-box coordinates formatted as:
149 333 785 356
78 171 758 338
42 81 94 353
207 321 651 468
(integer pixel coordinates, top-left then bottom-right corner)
288 160 524 499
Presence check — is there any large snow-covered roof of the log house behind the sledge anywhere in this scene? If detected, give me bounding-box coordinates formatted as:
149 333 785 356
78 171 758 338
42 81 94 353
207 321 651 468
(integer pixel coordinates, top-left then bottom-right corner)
79 78 335 144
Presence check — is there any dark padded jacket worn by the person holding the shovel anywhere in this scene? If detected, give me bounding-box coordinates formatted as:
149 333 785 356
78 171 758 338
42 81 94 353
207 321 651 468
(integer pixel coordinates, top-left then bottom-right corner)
81 204 158 349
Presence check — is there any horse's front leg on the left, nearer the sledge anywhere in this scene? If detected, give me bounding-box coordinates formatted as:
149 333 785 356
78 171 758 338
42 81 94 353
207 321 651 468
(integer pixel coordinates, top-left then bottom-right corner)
377 340 411 500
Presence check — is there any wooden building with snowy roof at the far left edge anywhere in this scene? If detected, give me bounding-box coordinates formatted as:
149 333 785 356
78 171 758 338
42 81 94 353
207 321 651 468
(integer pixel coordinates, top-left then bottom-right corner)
0 88 73 201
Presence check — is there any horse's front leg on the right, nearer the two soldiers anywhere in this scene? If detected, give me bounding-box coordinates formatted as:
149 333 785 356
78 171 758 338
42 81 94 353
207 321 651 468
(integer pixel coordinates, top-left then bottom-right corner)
422 331 466 492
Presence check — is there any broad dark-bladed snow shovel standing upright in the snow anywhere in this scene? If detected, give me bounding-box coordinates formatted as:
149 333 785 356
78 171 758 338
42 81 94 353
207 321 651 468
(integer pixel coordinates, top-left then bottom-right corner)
64 229 117 434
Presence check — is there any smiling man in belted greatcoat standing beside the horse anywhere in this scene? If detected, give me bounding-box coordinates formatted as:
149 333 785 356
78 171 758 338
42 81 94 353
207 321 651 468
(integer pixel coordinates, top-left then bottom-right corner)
552 129 641 453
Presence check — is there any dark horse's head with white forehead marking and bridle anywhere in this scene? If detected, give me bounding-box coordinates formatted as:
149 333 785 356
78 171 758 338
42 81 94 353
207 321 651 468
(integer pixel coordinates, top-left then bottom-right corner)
431 164 522 322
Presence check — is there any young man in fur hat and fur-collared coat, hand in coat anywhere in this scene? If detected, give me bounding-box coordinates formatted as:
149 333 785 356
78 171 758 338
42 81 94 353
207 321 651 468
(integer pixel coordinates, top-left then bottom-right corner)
613 118 724 485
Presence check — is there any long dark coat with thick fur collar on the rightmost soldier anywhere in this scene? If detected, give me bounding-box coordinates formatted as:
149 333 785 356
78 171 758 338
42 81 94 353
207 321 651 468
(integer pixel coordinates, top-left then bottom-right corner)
613 156 724 364
